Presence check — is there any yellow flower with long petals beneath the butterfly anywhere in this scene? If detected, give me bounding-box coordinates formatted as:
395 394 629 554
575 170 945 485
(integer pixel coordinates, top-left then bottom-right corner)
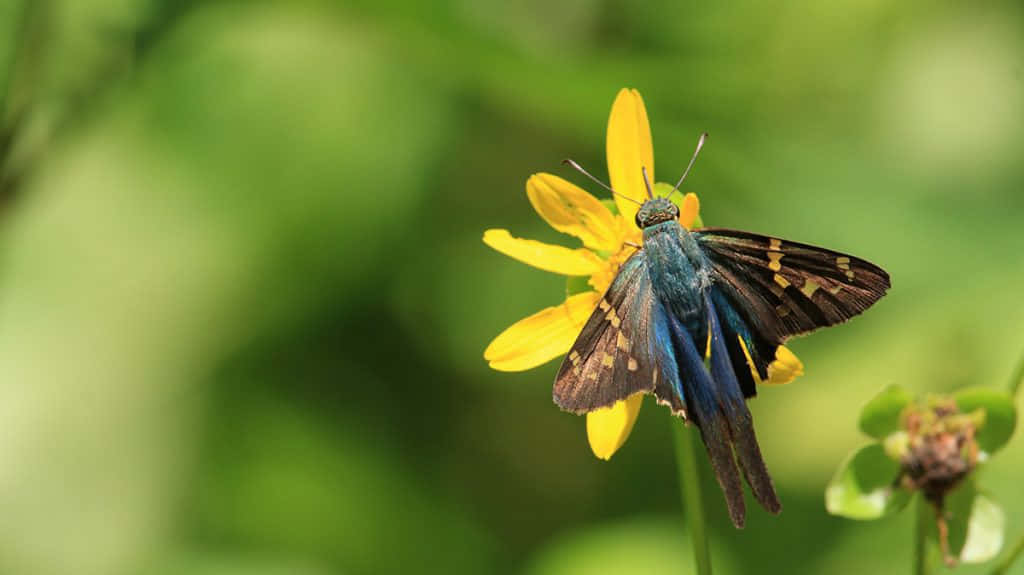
483 88 803 459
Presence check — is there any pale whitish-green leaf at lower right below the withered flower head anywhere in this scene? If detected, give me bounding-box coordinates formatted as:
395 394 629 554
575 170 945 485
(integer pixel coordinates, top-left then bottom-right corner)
928 481 1006 563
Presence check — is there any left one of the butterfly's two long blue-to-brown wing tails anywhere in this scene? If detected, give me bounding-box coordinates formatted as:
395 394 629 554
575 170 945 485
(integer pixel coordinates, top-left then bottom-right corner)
650 296 746 528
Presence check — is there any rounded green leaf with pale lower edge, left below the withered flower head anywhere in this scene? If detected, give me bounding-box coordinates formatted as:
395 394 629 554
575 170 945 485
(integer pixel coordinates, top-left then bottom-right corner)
825 443 910 520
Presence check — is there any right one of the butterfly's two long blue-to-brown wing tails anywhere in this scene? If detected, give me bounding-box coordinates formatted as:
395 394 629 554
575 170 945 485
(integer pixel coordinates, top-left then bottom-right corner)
706 298 782 514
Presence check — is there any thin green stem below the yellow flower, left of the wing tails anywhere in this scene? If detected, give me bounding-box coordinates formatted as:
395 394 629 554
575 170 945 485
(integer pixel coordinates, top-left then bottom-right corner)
671 417 711 575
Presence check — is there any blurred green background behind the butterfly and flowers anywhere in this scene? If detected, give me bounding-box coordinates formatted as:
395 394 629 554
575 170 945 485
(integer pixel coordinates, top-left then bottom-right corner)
0 0 1024 575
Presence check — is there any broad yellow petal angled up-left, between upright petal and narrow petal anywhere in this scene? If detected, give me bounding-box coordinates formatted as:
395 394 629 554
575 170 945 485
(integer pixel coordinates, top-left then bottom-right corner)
526 174 622 252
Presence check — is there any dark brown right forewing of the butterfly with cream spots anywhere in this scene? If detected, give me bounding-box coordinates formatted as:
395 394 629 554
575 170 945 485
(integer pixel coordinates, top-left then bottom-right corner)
694 228 889 343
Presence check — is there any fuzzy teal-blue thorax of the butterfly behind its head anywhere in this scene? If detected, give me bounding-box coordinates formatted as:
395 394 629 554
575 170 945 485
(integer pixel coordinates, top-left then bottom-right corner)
643 216 711 329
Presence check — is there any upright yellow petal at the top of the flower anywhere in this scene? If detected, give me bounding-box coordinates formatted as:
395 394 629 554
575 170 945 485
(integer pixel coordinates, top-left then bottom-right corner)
605 88 654 225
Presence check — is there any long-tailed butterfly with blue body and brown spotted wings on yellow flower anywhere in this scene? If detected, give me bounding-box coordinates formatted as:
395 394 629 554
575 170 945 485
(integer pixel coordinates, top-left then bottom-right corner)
553 153 890 528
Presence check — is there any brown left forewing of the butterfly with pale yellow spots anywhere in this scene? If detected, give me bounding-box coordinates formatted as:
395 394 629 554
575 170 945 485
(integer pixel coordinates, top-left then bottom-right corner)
552 252 655 413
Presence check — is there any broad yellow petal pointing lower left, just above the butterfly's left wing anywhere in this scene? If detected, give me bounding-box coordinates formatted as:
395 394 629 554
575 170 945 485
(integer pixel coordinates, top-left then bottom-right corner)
483 292 601 371
